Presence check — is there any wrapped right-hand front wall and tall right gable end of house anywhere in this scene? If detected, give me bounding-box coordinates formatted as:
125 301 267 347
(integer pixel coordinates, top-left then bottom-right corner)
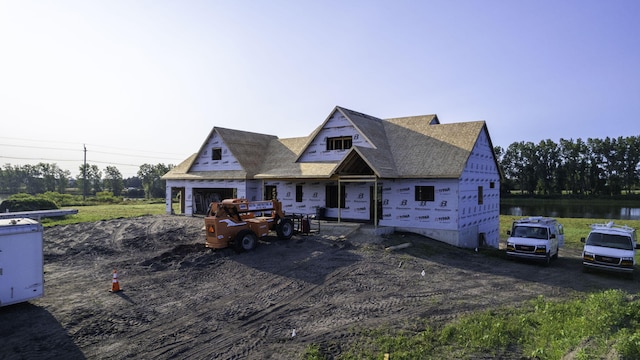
379 134 500 248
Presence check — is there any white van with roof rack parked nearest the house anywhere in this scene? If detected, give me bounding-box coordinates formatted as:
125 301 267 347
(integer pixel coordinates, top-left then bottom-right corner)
507 216 564 265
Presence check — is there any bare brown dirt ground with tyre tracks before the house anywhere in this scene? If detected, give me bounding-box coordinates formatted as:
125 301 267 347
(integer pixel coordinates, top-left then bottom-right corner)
0 215 640 359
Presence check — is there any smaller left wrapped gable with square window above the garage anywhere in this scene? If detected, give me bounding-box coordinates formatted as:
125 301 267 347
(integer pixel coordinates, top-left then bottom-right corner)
190 128 242 171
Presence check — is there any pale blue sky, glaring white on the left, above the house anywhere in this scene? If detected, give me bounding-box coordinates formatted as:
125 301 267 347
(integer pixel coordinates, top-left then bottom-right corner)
0 0 640 177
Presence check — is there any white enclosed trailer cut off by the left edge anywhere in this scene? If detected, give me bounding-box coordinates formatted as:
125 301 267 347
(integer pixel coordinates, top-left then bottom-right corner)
0 218 44 306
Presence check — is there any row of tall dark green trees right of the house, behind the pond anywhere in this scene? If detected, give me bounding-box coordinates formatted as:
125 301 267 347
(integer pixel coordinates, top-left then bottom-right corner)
494 136 640 196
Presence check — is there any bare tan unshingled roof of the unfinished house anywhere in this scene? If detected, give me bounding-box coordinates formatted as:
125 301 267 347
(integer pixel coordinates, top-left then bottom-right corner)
163 107 486 180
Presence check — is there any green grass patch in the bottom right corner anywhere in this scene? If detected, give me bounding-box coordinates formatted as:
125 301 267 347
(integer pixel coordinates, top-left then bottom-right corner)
312 290 640 360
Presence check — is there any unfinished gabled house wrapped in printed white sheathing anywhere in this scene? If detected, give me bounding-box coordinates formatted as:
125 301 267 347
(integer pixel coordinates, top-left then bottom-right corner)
163 107 501 248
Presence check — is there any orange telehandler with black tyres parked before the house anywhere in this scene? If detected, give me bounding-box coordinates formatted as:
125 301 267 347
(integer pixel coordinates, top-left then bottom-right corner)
204 199 294 252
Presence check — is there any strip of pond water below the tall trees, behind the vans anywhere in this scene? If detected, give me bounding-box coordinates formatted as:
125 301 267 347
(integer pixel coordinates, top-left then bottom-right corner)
500 201 640 220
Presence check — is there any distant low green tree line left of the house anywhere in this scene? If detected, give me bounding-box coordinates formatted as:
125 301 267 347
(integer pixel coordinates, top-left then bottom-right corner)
0 163 174 198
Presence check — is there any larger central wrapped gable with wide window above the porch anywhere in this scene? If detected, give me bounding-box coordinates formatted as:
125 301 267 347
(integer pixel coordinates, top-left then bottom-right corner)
298 107 374 162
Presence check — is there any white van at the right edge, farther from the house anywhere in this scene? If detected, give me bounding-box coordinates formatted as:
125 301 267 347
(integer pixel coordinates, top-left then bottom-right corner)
580 221 638 277
